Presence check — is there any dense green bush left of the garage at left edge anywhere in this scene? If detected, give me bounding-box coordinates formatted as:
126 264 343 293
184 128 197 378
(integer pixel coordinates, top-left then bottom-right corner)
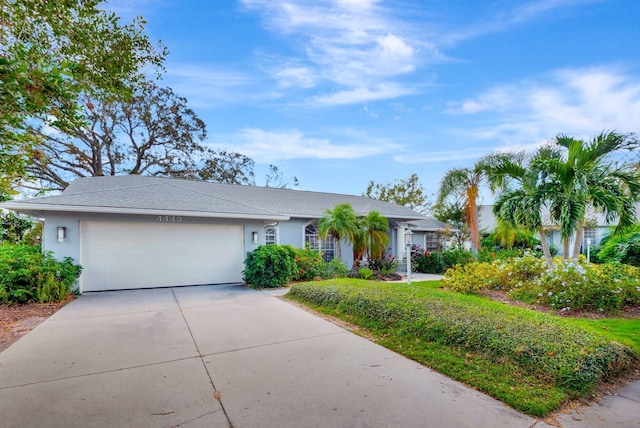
0 244 82 303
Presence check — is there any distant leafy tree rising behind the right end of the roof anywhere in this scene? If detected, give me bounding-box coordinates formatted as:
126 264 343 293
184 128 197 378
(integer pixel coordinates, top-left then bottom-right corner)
363 174 431 214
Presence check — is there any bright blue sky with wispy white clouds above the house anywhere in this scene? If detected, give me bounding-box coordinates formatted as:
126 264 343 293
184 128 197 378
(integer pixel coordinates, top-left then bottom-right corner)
107 0 640 202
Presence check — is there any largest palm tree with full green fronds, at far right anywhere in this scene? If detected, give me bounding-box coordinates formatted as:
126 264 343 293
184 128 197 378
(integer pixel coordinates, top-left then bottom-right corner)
543 132 640 258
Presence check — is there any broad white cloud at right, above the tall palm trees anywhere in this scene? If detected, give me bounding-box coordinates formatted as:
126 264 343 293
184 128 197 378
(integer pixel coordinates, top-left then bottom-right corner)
445 67 640 147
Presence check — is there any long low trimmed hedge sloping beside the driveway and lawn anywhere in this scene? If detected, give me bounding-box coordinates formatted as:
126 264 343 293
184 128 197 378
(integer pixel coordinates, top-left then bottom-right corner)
287 281 638 411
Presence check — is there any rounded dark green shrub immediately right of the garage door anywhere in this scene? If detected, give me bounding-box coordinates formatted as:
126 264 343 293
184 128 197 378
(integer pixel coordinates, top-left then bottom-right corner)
242 245 296 288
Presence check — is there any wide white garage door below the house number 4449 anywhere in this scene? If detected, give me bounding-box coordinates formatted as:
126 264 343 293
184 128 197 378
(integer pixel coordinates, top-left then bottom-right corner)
80 221 244 291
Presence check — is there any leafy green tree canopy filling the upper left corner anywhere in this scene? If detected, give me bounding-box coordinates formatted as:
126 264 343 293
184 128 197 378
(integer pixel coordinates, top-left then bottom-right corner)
0 0 166 193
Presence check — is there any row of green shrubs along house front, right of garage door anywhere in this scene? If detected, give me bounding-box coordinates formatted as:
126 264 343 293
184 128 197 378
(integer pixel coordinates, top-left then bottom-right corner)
243 245 348 288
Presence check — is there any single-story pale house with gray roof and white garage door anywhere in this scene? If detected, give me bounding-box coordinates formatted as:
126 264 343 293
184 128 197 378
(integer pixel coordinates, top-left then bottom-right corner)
0 175 430 292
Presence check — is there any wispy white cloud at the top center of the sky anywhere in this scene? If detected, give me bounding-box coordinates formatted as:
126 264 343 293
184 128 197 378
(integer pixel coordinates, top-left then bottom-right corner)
242 0 428 104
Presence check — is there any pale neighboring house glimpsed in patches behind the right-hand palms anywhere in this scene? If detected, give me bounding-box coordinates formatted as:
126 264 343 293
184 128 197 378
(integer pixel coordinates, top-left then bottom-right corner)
478 202 640 254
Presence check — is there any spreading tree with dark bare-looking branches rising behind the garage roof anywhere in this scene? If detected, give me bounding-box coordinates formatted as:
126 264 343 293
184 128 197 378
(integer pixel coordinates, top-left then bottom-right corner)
27 82 206 190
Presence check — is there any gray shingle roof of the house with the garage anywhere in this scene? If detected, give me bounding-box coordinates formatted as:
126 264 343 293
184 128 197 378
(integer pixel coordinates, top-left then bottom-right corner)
3 175 435 221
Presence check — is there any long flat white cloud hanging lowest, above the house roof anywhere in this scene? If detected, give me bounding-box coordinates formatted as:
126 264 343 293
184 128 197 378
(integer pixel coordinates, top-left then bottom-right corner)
208 128 399 163
